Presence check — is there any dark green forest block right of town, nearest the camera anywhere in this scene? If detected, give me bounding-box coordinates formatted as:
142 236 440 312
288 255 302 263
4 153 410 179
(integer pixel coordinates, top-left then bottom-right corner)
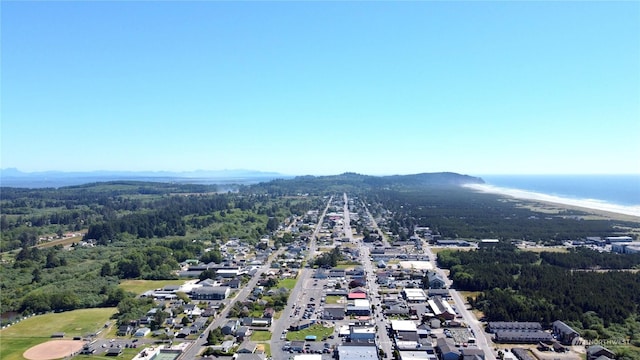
438 244 640 344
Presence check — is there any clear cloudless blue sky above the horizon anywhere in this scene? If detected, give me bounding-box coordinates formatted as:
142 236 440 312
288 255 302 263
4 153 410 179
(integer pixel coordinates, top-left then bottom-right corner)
0 1 640 175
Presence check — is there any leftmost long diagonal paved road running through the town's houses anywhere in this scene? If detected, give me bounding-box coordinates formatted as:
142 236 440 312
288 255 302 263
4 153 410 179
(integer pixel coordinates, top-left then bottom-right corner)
178 248 284 360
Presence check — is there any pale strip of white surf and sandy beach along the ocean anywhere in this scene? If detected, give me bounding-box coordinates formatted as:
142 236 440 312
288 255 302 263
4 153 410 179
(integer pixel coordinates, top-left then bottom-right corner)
464 184 640 221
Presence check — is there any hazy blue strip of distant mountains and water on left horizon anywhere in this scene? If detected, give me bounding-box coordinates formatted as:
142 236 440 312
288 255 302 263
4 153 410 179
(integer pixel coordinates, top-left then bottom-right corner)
0 168 293 188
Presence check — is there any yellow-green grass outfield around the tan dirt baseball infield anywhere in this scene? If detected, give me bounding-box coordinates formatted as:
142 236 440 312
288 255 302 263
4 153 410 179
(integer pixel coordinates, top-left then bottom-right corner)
0 308 117 360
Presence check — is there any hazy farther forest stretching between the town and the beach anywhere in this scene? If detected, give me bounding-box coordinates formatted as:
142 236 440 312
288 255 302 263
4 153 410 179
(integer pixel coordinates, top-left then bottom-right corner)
364 185 638 245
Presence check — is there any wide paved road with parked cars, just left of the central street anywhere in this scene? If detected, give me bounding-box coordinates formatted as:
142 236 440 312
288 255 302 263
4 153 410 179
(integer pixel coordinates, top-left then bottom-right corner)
270 197 333 360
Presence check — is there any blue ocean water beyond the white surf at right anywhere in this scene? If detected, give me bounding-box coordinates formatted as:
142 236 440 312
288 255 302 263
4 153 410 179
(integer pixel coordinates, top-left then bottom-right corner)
481 174 640 206
